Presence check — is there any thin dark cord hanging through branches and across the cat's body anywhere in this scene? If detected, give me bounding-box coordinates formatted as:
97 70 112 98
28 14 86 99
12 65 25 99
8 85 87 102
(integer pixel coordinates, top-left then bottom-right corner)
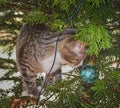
36 0 82 108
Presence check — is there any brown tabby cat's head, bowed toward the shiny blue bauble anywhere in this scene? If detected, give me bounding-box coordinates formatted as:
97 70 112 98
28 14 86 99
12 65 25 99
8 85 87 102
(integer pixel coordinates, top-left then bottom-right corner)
60 36 88 68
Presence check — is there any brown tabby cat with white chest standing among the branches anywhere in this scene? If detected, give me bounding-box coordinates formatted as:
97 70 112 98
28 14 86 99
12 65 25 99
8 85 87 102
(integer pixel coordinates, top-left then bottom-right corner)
16 24 87 97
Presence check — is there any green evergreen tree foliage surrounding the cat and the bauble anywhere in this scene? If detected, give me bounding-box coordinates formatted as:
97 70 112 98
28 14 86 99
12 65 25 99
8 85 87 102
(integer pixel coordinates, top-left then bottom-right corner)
0 0 120 108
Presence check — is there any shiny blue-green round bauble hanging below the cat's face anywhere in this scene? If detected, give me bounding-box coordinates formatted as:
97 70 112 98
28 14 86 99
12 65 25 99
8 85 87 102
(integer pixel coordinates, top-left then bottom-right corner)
80 65 99 83
